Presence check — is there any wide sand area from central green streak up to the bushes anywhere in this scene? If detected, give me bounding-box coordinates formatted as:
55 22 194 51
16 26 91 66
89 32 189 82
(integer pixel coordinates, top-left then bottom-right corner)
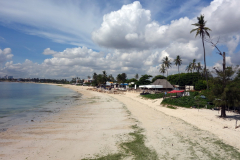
111 90 240 159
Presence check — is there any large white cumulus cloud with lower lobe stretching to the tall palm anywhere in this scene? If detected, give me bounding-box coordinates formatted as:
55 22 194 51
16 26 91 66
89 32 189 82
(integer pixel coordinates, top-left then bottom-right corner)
92 1 197 49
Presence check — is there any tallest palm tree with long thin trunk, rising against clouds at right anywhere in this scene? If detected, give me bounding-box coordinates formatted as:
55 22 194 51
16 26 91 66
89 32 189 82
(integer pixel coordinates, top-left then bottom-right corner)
190 15 211 89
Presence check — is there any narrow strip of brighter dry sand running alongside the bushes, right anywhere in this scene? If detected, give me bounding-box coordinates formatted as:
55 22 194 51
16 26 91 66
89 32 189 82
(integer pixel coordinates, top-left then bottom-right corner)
110 92 240 150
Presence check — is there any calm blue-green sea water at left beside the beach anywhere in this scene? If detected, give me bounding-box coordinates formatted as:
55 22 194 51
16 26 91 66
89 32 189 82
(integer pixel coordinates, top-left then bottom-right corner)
0 82 80 131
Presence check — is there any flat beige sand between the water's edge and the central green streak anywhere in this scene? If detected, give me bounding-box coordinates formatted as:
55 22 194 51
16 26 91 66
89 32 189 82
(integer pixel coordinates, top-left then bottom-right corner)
0 85 134 160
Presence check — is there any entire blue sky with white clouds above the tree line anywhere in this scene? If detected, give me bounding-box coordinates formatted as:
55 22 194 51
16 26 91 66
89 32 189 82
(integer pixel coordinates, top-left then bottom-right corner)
0 0 240 80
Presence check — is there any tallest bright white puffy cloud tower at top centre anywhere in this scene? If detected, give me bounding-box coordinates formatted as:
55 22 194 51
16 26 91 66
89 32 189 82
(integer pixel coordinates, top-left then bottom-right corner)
92 1 151 49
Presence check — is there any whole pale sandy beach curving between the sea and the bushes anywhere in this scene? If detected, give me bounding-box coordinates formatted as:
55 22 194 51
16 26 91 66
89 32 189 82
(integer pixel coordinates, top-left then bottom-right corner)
0 85 240 160
